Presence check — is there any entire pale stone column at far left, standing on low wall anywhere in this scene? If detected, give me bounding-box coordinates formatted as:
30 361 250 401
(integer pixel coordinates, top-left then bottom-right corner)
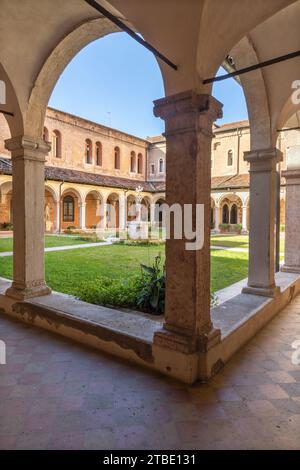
5 136 51 299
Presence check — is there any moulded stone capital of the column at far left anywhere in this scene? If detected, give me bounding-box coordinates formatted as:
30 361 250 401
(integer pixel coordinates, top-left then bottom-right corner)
5 135 51 162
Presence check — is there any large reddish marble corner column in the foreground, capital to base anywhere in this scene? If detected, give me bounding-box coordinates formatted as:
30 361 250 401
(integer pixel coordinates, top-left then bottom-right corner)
154 91 221 354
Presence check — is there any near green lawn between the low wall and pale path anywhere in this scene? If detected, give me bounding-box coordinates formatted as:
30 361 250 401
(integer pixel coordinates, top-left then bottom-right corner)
0 245 248 295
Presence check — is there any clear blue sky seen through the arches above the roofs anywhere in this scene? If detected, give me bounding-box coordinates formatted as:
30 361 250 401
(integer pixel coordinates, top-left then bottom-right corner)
49 33 247 137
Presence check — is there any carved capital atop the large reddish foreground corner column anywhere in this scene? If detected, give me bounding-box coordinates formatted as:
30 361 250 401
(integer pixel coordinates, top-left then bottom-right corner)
154 90 223 134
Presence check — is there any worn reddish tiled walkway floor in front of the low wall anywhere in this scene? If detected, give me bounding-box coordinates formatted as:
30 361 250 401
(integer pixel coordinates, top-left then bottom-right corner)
0 297 300 449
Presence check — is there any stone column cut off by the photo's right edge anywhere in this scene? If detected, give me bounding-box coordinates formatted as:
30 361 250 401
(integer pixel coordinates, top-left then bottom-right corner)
281 168 300 273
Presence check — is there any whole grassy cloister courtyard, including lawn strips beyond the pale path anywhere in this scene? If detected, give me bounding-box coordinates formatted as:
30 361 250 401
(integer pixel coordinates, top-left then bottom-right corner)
0 234 264 298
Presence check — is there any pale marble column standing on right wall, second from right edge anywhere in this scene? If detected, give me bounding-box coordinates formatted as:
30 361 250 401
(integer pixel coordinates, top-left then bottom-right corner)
243 148 282 297
